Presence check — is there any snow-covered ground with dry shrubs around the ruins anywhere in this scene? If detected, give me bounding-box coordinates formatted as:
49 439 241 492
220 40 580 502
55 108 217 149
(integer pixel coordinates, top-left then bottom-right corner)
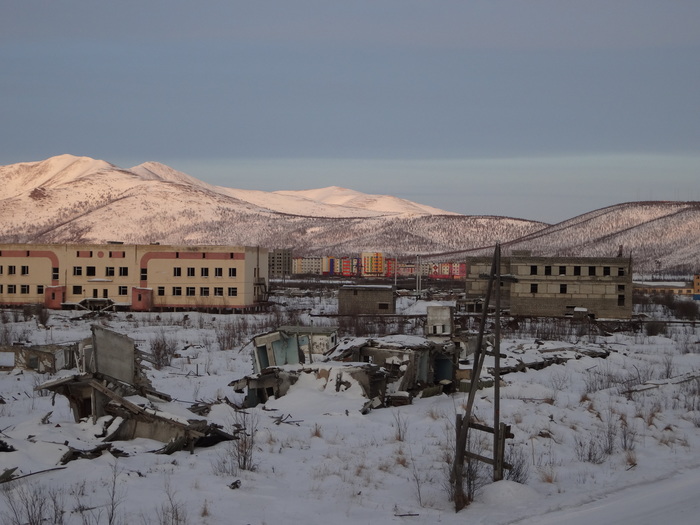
0 298 700 524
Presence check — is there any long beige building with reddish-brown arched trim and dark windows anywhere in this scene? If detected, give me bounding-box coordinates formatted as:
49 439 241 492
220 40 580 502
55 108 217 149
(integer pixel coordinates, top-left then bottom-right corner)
0 243 268 312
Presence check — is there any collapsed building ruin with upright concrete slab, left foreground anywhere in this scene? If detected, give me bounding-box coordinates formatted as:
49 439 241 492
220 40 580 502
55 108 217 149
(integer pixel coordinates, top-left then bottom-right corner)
36 325 230 447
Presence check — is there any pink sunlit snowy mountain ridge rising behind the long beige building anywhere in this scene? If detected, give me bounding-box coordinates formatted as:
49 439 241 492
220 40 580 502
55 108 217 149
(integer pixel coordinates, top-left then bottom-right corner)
0 155 544 255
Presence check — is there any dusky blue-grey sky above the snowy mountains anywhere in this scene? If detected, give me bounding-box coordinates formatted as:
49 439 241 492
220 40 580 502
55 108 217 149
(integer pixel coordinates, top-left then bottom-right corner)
0 0 700 223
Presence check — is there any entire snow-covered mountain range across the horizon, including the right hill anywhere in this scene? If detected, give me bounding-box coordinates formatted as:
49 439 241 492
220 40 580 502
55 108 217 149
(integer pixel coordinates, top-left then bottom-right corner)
0 155 700 273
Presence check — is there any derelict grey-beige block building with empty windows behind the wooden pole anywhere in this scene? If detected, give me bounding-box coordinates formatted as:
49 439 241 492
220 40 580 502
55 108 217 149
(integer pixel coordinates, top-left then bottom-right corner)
466 252 632 319
